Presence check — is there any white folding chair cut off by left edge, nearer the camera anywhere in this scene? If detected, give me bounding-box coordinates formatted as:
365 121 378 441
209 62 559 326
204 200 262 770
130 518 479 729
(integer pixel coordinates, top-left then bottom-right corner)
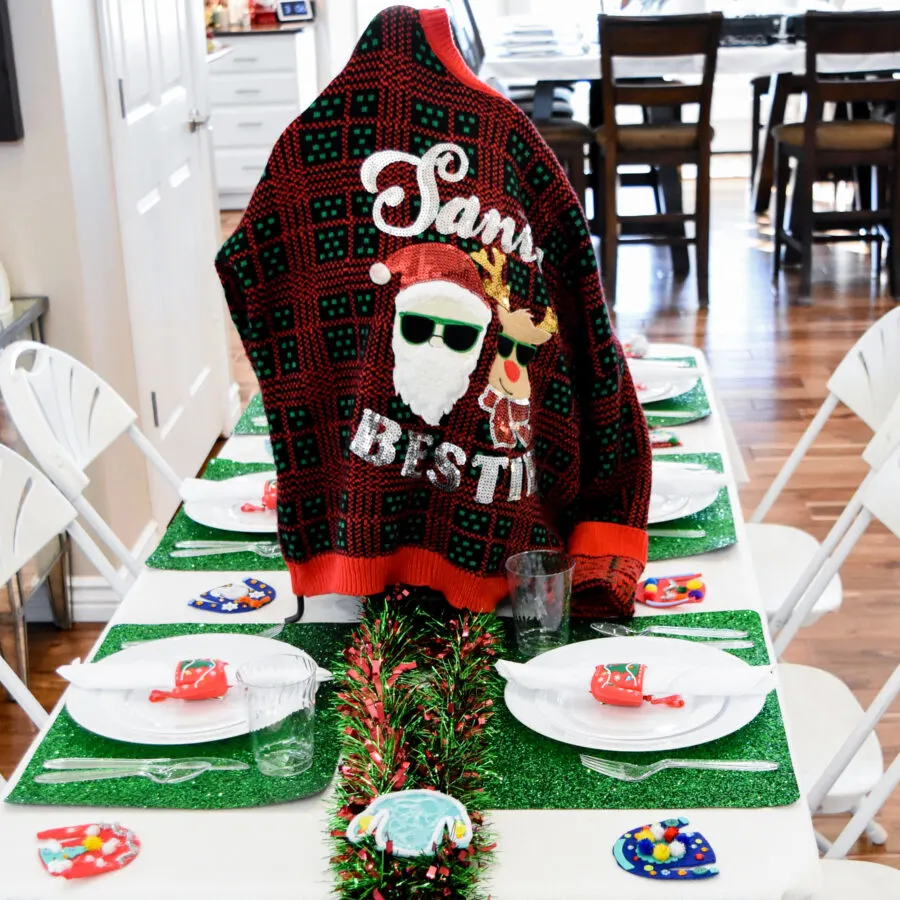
0 445 128 768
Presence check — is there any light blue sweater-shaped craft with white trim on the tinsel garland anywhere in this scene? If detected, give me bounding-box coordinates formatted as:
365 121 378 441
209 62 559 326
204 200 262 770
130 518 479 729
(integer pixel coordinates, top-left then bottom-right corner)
347 790 472 857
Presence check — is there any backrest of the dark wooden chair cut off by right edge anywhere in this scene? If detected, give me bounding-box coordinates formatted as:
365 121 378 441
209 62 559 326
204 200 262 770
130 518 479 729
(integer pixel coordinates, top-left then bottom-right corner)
803 12 900 158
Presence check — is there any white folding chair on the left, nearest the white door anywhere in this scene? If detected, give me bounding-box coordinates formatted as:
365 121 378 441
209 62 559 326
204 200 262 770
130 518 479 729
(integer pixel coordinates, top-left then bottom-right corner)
0 341 181 576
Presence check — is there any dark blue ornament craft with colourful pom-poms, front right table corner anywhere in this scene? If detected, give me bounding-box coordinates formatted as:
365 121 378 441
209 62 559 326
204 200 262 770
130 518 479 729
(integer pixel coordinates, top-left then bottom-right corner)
613 816 719 881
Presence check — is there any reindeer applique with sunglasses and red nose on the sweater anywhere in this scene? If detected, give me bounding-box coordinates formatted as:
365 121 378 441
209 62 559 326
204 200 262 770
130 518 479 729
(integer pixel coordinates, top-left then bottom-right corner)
471 247 557 450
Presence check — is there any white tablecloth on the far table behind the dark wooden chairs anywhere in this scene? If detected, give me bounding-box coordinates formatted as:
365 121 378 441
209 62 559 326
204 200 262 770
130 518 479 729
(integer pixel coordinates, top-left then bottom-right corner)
479 44 900 84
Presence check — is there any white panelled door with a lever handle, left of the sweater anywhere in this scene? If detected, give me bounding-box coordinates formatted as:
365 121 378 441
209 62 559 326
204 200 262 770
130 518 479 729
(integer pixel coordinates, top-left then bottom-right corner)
101 0 231 523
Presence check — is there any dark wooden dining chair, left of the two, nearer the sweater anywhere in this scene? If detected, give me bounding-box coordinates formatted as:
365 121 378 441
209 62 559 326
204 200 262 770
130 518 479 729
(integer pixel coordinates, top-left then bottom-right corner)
594 13 722 306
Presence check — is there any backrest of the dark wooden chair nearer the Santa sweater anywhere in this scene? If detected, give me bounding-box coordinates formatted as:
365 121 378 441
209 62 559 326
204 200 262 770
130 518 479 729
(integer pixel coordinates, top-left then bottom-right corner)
598 13 722 148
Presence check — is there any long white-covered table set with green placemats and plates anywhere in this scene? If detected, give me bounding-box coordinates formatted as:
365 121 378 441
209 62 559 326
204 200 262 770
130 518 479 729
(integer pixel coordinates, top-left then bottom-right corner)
0 345 817 900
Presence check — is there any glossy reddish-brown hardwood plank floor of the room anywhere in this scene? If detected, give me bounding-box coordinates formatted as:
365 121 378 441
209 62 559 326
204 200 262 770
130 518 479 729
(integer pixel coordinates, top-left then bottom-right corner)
0 181 900 868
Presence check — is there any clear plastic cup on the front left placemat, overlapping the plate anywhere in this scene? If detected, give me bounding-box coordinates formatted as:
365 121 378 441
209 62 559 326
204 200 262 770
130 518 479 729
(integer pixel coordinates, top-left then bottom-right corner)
237 653 316 778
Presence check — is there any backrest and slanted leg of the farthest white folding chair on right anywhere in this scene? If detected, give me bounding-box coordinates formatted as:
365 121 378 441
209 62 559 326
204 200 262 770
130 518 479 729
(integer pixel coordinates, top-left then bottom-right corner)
750 306 900 522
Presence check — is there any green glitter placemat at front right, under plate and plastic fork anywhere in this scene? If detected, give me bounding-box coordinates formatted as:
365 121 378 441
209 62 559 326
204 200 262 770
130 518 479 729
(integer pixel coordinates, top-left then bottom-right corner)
485 610 800 809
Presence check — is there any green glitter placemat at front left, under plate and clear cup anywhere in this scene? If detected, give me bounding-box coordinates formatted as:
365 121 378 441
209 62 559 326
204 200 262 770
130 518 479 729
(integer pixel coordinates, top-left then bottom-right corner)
6 624 352 809
